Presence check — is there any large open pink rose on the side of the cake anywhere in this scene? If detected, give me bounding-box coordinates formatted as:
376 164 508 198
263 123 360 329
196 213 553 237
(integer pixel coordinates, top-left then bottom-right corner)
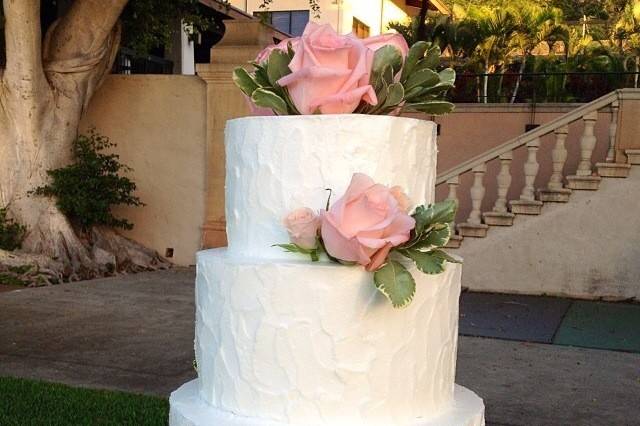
320 173 416 270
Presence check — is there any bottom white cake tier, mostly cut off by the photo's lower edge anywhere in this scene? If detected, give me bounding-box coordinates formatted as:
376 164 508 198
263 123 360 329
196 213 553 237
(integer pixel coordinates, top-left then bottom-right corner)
169 379 484 426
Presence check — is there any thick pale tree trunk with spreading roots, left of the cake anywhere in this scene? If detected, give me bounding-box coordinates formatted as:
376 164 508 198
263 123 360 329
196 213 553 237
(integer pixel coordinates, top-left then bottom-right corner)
0 0 168 281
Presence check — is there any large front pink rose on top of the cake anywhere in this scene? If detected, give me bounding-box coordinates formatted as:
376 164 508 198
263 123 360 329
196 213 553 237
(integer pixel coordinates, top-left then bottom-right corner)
278 22 378 114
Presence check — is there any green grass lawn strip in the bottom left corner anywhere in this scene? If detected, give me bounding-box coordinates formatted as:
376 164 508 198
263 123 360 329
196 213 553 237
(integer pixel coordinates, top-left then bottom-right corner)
0 377 169 426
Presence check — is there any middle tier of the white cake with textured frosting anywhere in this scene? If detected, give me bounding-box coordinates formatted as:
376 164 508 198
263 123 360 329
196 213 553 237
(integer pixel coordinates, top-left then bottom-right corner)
196 249 461 426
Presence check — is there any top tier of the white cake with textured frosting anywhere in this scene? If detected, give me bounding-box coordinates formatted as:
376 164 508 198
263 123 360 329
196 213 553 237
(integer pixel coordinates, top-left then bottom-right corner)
225 114 437 259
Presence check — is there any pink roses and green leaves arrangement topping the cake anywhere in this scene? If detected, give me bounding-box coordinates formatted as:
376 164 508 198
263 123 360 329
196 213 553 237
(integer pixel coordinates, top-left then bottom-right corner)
233 22 456 115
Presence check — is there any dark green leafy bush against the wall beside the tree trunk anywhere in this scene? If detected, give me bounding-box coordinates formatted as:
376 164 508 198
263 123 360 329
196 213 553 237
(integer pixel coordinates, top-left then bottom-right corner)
32 129 144 231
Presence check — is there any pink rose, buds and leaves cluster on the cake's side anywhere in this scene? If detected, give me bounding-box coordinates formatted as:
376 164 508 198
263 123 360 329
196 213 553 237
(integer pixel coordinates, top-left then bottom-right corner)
277 173 459 308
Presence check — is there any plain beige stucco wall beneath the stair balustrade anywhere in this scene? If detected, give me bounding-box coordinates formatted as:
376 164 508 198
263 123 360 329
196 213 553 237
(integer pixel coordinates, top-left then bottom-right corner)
456 166 640 300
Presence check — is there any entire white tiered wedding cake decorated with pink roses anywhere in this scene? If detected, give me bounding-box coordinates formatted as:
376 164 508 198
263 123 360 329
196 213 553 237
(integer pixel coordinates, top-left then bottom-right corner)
170 26 484 426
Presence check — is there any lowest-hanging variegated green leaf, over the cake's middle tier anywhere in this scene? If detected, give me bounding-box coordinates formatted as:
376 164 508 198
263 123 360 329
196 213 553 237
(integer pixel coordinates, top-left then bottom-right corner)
373 260 416 308
